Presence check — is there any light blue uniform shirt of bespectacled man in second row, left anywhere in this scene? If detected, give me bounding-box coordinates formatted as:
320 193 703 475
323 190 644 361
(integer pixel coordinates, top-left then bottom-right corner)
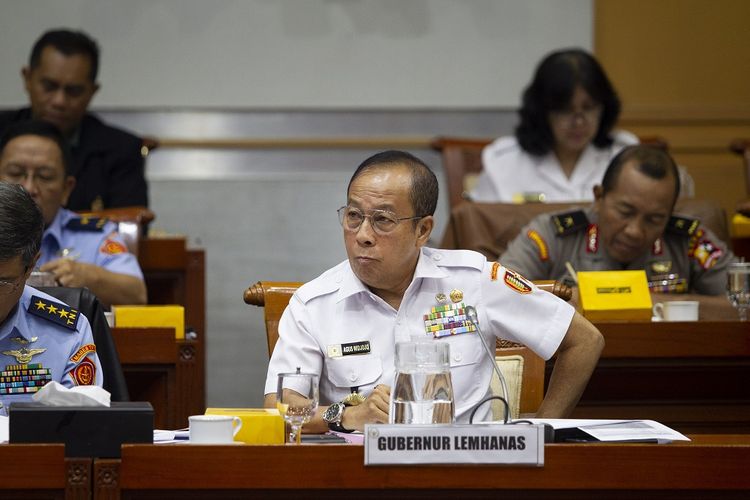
37 208 143 280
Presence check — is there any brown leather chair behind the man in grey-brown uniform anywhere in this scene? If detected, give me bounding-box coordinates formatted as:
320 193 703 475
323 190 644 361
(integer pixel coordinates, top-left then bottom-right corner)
440 198 729 260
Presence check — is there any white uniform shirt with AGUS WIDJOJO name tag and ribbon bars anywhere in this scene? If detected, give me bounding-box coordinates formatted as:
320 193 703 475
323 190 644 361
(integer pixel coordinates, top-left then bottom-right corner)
265 248 574 422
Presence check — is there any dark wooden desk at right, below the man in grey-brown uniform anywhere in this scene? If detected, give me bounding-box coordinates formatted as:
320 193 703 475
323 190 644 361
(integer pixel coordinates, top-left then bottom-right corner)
568 321 750 433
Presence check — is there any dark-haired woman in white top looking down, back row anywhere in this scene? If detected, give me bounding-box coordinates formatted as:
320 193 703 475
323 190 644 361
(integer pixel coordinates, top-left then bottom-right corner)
471 49 638 202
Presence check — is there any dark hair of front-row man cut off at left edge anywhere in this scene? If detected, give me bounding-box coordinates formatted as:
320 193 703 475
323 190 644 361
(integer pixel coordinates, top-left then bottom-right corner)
0 182 44 268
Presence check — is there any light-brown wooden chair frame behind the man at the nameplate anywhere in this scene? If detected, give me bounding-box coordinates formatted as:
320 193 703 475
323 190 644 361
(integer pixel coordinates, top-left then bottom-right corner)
243 281 572 416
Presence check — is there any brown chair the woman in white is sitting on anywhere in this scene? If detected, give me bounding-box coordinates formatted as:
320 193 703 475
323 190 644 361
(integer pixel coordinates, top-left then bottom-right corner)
430 137 672 208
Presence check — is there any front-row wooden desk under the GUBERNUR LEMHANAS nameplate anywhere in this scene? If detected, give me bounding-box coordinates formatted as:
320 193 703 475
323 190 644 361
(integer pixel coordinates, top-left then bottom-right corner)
88 435 750 500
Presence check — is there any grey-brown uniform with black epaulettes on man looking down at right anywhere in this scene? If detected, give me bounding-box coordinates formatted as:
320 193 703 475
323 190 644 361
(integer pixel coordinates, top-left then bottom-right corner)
500 208 735 295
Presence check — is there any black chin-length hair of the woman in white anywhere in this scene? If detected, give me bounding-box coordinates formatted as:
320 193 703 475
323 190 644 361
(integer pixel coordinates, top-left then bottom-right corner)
516 49 620 156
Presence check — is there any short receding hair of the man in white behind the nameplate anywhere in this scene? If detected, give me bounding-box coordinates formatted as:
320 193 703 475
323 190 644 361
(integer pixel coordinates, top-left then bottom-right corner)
346 150 439 217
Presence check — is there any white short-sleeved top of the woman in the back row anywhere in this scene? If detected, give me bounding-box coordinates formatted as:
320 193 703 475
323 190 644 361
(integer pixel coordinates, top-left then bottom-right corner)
471 131 638 203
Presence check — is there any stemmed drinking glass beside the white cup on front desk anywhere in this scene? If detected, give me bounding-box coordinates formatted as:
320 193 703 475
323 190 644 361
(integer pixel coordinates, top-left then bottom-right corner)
276 368 318 444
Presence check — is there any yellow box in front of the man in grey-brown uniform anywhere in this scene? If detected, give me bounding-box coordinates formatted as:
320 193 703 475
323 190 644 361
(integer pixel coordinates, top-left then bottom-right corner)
578 271 652 321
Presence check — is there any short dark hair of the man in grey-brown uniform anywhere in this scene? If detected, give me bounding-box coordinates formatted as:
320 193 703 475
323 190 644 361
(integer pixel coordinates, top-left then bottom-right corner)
602 144 680 208
